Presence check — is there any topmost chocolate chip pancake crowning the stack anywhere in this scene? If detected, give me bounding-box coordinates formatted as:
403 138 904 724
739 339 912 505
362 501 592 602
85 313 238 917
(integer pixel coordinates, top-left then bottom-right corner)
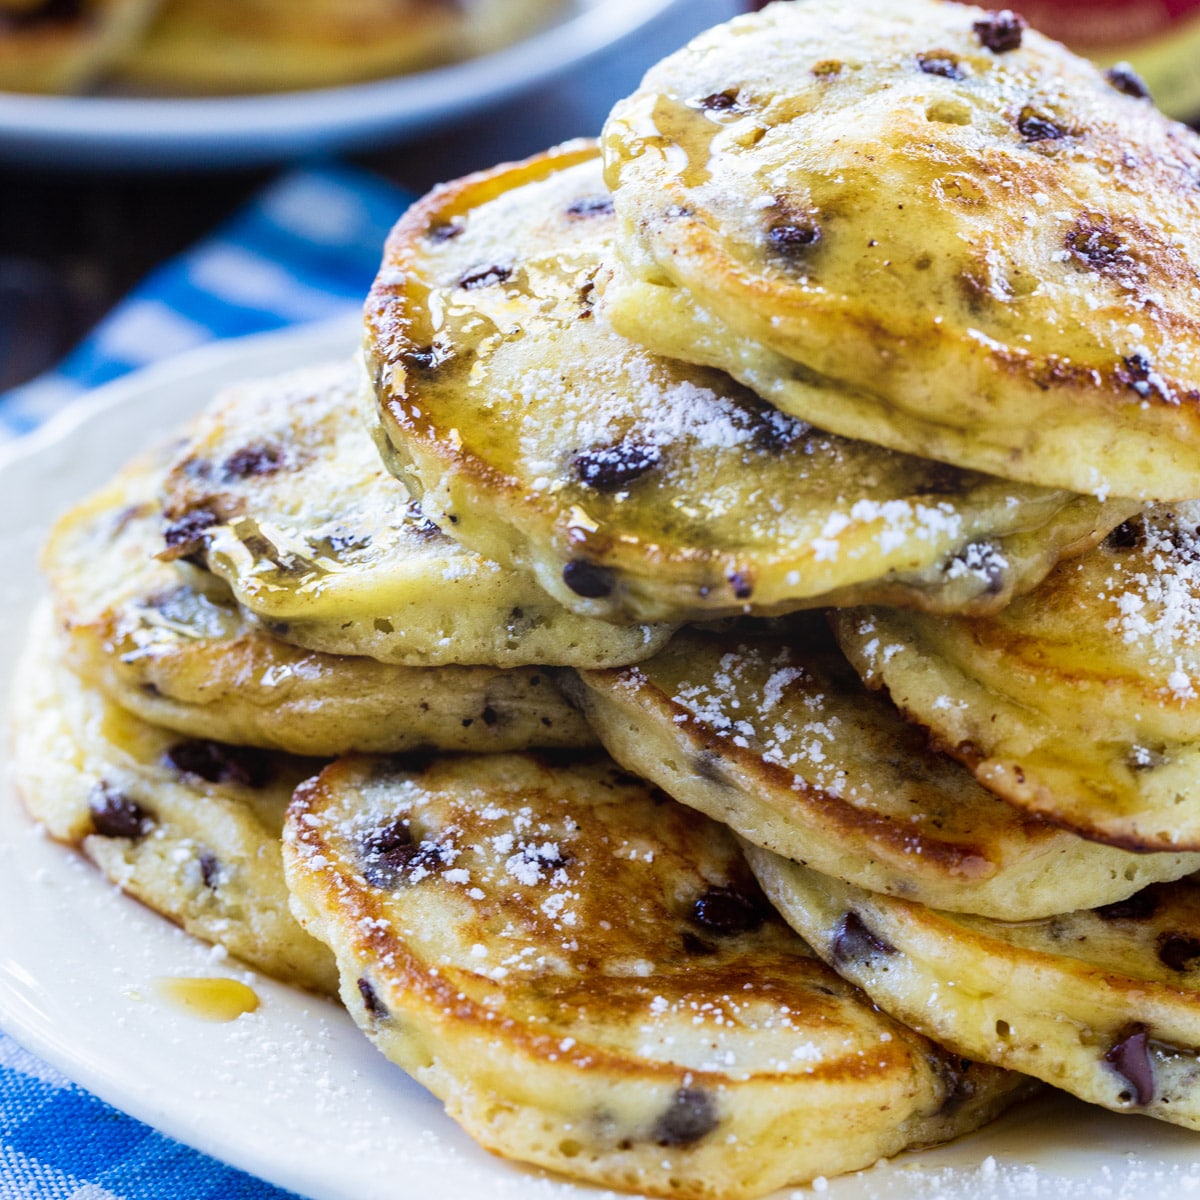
604 0 1200 500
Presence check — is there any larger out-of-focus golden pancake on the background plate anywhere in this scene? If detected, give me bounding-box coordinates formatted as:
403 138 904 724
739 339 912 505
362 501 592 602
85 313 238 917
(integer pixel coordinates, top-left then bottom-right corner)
120 0 558 92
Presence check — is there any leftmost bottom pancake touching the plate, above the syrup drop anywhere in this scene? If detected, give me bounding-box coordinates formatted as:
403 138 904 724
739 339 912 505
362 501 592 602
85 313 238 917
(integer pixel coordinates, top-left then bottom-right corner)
11 610 337 994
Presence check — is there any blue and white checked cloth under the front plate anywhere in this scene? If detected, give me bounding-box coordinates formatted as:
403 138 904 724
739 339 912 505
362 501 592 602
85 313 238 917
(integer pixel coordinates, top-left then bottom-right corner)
0 159 409 1200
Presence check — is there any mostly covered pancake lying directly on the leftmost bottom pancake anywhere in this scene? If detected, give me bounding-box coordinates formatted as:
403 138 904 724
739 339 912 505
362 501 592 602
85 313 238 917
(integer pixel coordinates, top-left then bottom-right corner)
42 446 595 756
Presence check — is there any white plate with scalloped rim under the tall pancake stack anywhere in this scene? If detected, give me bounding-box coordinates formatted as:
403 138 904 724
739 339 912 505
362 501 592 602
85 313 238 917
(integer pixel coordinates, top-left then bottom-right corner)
7 319 1200 1200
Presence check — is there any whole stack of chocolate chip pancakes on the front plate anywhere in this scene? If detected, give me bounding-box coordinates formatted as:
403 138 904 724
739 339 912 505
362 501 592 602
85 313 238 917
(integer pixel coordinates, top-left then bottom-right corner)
17 0 1200 1196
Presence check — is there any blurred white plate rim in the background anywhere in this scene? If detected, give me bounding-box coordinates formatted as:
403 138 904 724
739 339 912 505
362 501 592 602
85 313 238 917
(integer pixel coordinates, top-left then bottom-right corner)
0 0 678 168
